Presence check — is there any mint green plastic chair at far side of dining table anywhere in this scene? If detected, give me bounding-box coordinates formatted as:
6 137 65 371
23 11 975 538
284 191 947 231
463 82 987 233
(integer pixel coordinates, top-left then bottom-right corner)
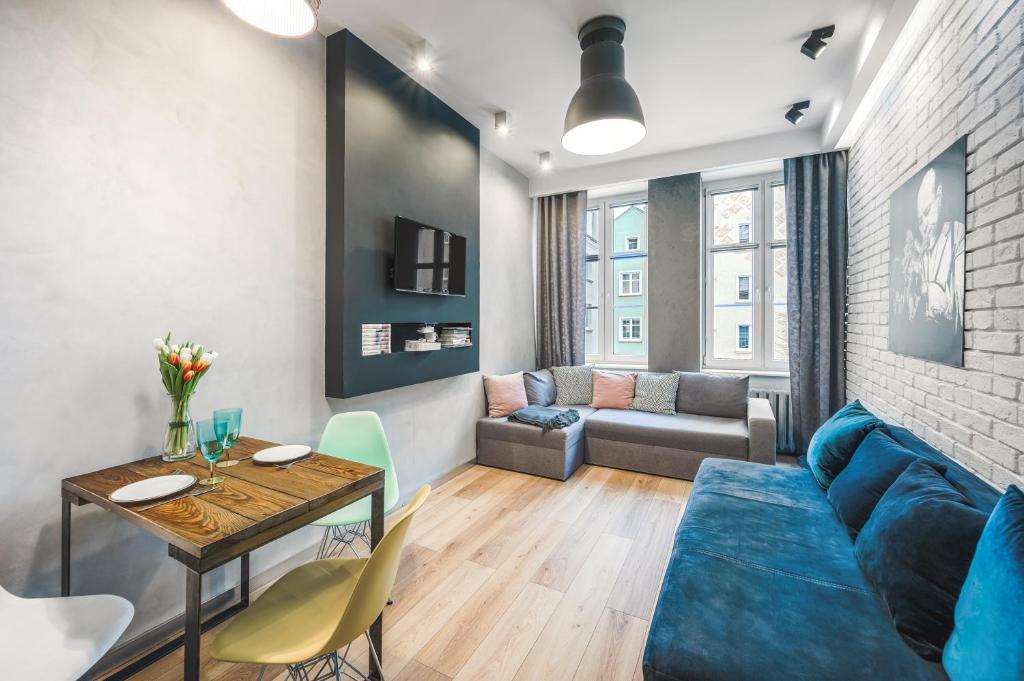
312 412 398 559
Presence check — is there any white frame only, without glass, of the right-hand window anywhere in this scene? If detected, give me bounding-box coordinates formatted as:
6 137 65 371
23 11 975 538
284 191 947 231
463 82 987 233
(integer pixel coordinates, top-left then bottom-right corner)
700 172 790 374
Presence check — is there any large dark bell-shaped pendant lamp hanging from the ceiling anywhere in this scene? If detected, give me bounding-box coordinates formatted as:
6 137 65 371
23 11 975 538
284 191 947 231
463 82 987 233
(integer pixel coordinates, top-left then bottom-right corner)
562 16 647 156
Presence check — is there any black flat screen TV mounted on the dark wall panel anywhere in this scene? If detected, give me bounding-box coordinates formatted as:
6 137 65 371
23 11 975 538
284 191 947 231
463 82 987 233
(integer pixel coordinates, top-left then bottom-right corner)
394 215 466 296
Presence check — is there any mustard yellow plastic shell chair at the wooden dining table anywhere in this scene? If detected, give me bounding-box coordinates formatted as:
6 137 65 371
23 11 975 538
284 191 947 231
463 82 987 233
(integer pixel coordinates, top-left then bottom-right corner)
210 484 430 681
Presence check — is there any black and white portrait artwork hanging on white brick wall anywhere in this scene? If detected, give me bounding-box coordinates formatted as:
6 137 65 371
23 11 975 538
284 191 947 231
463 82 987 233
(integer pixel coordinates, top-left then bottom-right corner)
889 136 967 367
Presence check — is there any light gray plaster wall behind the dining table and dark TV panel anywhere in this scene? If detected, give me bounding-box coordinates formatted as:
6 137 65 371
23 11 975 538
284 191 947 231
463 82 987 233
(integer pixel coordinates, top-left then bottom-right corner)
0 0 534 636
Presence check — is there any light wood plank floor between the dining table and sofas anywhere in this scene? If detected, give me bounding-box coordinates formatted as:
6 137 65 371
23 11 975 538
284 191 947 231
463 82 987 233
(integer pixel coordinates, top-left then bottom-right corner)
123 466 690 681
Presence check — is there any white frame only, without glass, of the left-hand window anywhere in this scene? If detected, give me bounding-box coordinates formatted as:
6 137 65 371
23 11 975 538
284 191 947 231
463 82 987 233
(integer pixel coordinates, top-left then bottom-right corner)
584 191 650 368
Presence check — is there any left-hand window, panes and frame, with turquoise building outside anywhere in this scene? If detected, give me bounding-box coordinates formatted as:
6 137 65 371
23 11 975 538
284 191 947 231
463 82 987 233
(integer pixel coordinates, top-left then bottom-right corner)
586 195 647 365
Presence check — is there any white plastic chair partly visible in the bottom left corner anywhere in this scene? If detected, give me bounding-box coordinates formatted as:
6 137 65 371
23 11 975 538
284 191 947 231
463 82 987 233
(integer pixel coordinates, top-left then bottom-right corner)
0 587 135 681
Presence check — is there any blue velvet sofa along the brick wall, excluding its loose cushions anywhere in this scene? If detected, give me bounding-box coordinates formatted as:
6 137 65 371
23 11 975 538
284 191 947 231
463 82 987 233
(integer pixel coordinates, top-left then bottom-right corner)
643 426 999 681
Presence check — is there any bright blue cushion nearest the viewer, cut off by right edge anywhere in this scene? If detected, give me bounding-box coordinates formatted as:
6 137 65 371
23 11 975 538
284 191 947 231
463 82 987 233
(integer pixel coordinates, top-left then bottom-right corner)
942 485 1024 681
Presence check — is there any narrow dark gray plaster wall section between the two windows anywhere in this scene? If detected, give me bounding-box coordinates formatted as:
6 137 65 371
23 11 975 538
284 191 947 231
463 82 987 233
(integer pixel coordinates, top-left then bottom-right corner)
647 173 701 372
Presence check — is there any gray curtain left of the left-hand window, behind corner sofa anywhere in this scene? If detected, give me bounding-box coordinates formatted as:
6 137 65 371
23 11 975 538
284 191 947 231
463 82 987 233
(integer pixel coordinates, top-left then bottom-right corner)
537 191 587 367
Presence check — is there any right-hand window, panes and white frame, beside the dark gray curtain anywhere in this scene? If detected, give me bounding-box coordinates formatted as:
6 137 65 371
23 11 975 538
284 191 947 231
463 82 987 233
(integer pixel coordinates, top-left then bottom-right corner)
703 175 788 371
